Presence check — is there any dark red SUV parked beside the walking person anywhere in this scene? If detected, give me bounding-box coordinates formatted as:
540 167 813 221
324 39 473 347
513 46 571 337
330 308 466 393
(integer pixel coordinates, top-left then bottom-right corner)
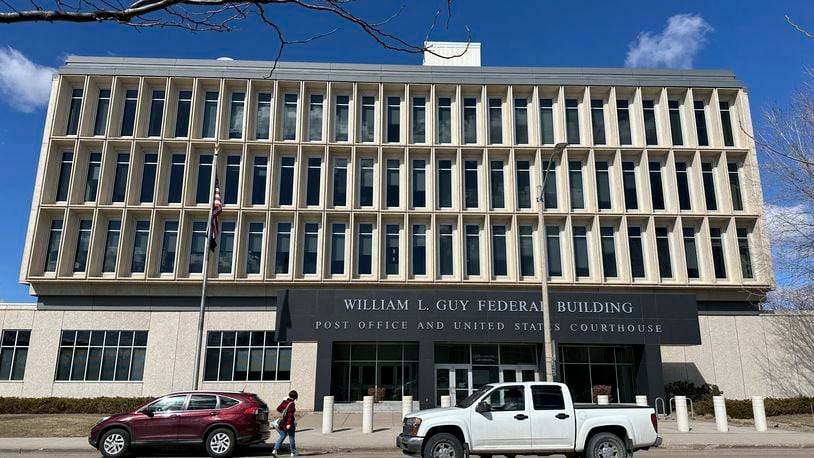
88 391 270 458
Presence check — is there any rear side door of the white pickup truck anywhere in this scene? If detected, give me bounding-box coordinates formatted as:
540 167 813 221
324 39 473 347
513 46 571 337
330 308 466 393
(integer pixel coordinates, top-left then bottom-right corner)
531 385 576 450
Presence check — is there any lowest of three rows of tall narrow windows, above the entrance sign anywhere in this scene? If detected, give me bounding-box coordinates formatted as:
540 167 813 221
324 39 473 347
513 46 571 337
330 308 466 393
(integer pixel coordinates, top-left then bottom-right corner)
44 219 754 279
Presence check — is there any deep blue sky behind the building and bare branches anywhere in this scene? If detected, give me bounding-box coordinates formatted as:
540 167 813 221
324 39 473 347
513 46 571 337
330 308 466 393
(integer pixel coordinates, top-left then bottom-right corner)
0 0 814 302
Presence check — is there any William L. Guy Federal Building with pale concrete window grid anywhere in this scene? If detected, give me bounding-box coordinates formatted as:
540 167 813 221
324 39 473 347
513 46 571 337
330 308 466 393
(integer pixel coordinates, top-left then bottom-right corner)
0 44 794 409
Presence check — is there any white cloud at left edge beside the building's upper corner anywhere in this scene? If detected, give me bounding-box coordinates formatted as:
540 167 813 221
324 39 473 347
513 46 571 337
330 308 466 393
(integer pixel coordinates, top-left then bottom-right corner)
0 47 56 113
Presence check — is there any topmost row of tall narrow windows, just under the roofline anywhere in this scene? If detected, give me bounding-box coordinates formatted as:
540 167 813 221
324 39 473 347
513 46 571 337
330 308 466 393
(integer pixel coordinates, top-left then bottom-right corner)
61 88 735 146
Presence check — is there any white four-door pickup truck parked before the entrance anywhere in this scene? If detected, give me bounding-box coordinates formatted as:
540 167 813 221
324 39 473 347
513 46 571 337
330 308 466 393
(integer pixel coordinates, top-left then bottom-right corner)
396 382 661 458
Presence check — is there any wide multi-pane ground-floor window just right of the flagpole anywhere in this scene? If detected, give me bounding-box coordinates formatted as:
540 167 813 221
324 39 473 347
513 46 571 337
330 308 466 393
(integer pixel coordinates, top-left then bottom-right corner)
204 331 291 382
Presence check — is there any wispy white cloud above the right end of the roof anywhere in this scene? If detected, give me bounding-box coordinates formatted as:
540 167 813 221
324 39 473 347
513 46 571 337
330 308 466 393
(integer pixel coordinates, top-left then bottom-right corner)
625 14 713 68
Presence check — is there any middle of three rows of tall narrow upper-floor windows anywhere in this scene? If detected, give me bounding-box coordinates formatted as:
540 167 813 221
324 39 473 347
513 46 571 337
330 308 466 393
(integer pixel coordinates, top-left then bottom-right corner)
54 152 744 211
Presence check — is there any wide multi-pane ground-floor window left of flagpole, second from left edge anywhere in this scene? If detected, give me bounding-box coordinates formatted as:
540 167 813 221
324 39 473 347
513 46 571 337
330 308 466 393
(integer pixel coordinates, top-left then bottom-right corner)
56 330 148 382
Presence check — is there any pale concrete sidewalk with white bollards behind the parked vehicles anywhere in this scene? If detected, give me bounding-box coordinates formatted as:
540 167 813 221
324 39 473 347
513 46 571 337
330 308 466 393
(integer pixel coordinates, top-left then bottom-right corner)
0 412 814 455
